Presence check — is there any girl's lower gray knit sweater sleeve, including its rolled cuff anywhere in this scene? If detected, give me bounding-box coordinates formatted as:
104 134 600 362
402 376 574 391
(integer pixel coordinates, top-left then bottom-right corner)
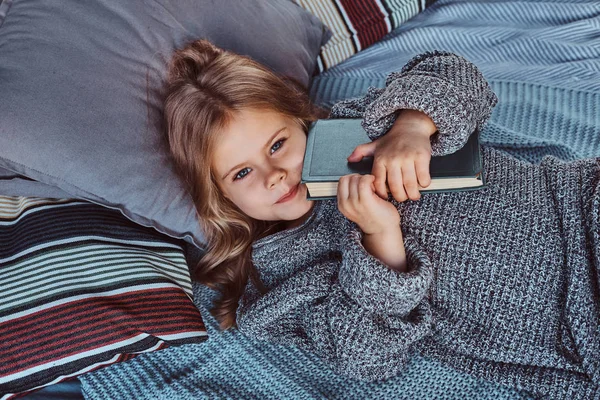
237 230 433 381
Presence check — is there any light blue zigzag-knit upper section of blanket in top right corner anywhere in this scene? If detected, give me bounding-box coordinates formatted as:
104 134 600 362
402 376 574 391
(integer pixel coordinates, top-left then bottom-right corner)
317 0 600 92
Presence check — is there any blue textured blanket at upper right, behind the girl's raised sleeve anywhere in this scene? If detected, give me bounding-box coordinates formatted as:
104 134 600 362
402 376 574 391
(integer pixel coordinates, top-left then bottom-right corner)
311 0 600 162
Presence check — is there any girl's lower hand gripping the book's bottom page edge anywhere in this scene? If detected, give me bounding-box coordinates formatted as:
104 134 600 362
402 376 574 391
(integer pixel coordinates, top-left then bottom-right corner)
337 174 400 235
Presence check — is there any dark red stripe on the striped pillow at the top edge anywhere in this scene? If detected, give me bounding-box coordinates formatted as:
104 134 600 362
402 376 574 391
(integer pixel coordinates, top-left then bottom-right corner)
340 0 388 49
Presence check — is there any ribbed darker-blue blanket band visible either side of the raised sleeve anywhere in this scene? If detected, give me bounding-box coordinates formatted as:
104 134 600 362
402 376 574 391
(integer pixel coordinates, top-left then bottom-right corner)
311 76 600 164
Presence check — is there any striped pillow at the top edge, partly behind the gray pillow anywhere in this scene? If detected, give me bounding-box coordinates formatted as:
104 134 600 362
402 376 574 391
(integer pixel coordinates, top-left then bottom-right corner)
294 0 435 72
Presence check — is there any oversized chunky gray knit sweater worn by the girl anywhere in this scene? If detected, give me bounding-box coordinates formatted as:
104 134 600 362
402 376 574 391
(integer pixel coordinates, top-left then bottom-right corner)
237 52 600 399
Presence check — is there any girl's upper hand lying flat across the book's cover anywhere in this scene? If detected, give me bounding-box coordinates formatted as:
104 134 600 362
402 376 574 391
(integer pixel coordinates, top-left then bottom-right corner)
348 110 437 202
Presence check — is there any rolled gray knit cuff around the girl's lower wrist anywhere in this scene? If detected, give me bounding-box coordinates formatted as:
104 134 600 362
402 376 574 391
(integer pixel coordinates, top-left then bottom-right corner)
339 228 433 317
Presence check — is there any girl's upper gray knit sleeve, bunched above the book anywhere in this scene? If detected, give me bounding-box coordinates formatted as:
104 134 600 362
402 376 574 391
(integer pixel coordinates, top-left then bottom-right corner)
331 51 498 156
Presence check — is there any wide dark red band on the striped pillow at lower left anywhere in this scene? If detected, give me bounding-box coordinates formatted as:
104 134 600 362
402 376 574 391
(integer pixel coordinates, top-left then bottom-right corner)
0 288 205 377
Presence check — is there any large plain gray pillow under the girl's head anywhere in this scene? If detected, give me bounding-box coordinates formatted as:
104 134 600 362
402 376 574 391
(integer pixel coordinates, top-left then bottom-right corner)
0 0 330 246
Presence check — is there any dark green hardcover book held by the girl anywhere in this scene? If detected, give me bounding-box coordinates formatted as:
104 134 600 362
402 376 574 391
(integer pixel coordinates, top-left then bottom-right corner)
301 118 485 200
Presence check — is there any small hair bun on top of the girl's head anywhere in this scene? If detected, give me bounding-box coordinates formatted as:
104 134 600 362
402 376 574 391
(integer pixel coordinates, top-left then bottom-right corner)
167 39 224 82
